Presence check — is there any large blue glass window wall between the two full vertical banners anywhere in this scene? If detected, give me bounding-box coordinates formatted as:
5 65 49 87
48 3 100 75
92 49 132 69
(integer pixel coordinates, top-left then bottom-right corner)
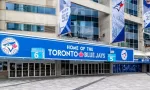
71 3 99 40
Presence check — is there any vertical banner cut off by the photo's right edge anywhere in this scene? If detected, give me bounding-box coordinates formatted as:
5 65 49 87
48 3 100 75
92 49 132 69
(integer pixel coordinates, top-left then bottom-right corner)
143 0 150 28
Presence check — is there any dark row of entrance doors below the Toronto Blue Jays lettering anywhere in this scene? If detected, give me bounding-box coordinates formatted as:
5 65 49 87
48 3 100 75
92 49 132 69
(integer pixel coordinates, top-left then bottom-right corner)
61 61 110 76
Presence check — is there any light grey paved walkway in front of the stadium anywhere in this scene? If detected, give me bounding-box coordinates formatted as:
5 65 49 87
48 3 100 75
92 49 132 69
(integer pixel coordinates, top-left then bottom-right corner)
0 73 150 90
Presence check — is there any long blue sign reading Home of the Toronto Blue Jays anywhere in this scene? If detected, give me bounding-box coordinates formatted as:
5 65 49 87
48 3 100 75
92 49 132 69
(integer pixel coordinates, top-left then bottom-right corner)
0 33 133 62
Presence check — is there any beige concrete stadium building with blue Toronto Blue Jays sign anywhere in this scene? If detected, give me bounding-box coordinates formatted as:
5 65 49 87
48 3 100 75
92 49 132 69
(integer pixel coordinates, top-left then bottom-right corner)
0 0 150 78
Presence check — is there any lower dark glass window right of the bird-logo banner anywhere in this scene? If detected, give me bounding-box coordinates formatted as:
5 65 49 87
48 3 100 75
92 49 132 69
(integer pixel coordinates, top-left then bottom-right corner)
119 20 138 50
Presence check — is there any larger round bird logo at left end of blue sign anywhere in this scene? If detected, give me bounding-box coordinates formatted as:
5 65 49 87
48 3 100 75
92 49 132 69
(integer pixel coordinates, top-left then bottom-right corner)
1 37 19 55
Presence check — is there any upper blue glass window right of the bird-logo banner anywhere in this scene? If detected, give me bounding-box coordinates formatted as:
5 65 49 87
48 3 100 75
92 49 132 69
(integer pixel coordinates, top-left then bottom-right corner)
125 0 138 16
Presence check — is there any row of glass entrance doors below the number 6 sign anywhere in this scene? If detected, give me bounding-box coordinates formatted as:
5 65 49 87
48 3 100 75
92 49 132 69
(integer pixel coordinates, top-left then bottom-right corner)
8 62 56 78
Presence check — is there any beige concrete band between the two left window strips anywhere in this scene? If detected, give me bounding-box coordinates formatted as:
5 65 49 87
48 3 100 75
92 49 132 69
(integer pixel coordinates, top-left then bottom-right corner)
5 10 56 26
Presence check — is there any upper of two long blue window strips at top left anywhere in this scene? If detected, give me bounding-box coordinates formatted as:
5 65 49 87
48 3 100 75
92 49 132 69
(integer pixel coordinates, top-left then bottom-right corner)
6 2 56 15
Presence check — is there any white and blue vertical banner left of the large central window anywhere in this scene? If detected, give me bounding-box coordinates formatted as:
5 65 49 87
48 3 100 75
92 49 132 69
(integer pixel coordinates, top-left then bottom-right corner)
59 0 71 35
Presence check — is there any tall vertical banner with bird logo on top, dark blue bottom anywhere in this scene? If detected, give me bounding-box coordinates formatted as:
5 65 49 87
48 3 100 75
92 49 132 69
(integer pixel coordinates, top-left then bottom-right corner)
112 0 125 43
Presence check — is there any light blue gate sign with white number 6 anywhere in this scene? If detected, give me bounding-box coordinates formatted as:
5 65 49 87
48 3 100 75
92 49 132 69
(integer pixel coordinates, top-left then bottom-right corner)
31 48 45 59
